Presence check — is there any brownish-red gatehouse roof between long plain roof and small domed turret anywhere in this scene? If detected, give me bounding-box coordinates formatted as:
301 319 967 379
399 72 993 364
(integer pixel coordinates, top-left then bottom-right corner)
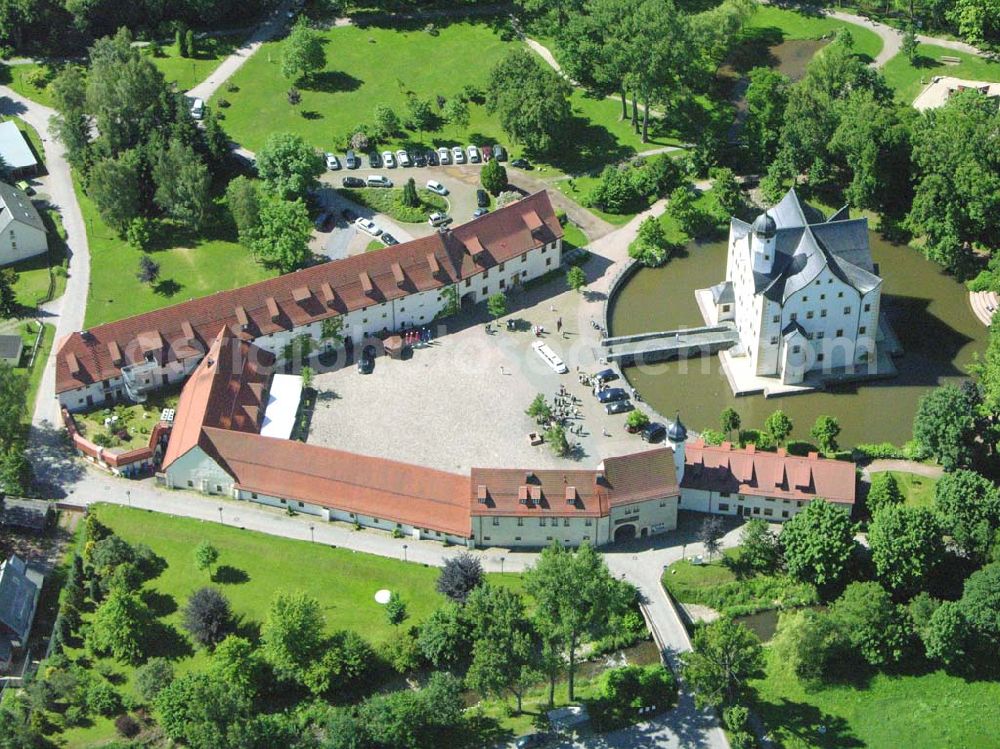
470 448 679 517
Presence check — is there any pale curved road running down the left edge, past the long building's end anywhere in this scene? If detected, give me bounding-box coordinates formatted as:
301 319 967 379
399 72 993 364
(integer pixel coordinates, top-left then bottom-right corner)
0 86 90 432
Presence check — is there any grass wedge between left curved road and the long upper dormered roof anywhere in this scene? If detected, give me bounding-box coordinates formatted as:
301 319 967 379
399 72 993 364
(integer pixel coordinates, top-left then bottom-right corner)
76 178 274 327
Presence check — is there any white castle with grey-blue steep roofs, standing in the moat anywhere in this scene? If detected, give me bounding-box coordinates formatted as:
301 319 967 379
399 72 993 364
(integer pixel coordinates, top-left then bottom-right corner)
709 189 882 385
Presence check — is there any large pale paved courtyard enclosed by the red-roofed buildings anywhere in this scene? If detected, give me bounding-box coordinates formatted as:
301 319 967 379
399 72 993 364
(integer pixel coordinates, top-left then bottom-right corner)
308 279 664 472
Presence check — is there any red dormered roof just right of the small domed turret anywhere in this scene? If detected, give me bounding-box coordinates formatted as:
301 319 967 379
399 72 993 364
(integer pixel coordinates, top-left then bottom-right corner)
681 440 856 504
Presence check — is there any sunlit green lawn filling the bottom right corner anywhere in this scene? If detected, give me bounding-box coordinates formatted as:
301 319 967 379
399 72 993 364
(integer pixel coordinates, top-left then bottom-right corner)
752 654 1000 749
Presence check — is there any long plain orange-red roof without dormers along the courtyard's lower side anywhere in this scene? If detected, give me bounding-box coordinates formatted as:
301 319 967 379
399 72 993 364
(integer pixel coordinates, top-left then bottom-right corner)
199 427 472 538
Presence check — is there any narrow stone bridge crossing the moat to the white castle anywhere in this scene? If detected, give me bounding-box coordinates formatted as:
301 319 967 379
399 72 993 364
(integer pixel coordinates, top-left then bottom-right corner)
601 323 739 366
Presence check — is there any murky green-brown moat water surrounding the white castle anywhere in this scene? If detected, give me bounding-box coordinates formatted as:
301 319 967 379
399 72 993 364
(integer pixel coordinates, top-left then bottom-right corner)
609 232 988 447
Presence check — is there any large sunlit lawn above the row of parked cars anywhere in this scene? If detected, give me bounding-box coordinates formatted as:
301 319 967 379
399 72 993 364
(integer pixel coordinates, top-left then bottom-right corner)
216 23 676 176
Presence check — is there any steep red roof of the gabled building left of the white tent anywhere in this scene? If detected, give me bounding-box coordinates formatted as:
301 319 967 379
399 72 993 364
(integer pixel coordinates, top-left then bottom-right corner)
163 328 274 469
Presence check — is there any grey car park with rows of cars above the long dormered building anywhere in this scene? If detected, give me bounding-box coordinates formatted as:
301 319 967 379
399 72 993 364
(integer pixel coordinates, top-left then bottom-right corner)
310 149 516 260
